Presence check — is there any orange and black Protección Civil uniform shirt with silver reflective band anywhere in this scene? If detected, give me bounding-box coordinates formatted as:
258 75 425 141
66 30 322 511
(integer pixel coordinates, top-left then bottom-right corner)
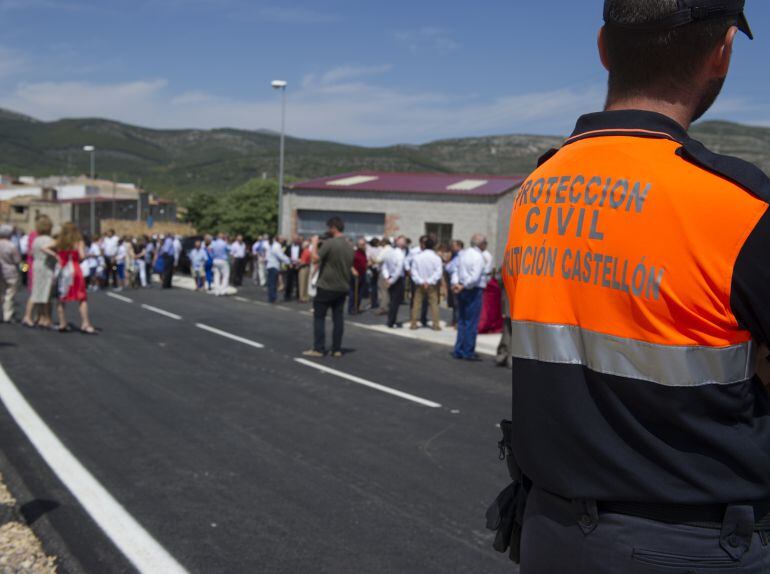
503 111 770 504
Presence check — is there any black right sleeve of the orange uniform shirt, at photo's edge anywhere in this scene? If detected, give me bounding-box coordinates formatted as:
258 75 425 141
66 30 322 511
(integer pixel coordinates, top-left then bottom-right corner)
730 210 770 344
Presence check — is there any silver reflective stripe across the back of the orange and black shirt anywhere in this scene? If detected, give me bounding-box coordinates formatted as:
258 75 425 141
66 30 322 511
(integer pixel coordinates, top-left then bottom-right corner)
512 321 757 387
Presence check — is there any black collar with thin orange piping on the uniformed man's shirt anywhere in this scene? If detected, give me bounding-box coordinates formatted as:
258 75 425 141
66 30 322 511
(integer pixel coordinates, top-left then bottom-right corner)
565 110 690 144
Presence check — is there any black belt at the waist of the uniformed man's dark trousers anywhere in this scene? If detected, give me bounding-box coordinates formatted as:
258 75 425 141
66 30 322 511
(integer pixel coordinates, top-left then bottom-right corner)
597 501 770 532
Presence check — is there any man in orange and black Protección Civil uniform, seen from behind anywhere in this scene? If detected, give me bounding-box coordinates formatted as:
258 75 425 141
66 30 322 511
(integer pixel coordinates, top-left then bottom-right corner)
493 0 770 574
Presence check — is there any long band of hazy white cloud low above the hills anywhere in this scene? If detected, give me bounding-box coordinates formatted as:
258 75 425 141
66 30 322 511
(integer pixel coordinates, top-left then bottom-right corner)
0 66 603 145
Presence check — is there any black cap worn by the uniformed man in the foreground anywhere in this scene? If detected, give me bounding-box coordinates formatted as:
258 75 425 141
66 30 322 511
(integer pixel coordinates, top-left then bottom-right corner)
604 0 754 40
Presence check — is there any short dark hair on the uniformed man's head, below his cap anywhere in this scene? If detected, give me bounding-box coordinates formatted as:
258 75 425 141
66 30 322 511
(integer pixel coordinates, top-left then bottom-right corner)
604 0 737 100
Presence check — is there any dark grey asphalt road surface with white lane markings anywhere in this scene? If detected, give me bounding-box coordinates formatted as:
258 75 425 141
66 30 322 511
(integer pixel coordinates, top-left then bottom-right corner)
0 289 513 574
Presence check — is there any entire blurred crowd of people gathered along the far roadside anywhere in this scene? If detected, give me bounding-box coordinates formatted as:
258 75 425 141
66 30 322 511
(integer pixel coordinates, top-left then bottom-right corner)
0 216 503 360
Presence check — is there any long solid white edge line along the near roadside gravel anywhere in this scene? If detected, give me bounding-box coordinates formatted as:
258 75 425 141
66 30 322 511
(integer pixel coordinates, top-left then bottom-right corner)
0 367 187 574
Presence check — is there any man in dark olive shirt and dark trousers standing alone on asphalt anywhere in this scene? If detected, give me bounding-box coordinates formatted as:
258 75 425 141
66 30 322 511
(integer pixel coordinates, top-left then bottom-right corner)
304 217 353 357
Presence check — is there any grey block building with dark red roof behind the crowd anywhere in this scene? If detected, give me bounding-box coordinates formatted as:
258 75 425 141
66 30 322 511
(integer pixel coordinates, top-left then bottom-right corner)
281 171 525 260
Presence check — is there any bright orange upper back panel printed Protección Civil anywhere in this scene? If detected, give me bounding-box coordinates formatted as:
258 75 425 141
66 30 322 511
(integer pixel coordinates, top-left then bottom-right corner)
503 136 768 347
